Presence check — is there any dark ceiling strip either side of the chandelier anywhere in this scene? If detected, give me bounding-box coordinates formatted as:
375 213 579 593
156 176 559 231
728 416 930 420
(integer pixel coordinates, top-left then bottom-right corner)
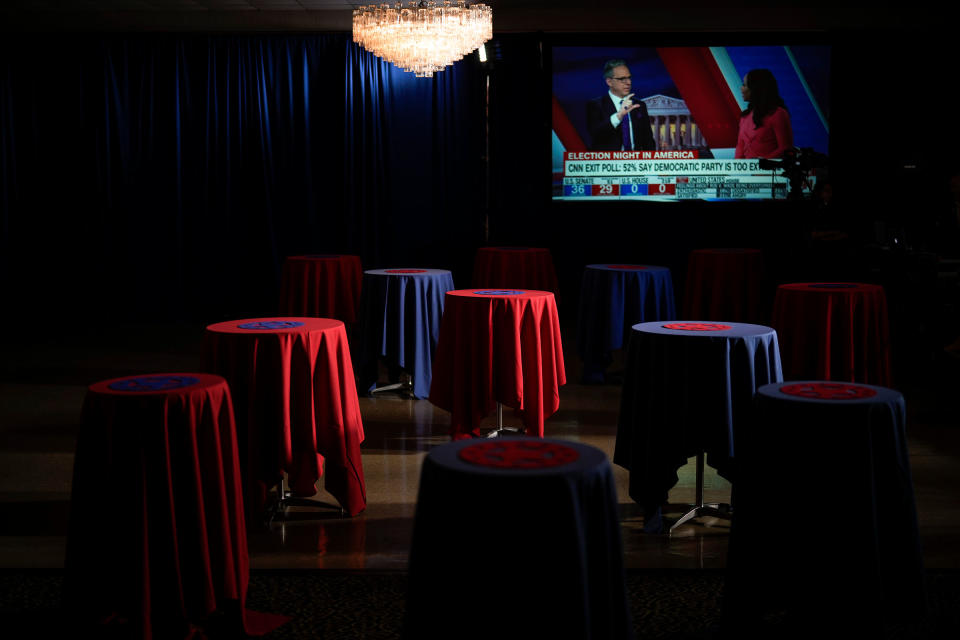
0 0 929 33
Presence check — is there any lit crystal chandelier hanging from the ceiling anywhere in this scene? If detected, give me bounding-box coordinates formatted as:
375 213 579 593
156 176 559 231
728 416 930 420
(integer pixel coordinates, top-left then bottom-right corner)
353 0 493 78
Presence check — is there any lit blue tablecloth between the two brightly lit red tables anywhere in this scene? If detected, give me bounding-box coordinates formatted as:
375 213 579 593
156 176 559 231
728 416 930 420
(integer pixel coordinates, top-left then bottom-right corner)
356 269 453 398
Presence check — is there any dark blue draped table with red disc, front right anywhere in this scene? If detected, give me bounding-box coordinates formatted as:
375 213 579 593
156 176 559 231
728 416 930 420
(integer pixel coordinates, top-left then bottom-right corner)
724 381 925 637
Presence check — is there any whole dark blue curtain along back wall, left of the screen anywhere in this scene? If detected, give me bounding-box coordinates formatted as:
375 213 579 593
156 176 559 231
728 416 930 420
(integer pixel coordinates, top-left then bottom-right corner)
0 34 483 322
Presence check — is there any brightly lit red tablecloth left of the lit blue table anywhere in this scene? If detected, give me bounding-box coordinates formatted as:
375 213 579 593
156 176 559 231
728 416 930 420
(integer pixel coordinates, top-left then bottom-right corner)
204 317 366 518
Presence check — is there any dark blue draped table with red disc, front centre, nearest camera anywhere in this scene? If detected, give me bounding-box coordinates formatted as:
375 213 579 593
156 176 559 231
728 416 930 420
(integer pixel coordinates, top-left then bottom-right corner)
403 438 632 640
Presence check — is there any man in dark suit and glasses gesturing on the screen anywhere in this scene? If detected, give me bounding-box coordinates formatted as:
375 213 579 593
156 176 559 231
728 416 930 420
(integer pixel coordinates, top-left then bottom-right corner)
587 60 656 151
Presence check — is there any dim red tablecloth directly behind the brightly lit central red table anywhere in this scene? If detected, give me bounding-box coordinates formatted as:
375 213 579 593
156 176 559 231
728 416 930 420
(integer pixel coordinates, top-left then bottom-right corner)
473 247 558 293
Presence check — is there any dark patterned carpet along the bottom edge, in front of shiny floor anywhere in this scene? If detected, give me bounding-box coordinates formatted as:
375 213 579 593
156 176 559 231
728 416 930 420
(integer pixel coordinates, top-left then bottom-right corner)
0 570 960 640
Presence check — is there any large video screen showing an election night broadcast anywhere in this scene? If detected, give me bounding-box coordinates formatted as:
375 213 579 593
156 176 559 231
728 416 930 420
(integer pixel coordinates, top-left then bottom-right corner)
551 45 830 201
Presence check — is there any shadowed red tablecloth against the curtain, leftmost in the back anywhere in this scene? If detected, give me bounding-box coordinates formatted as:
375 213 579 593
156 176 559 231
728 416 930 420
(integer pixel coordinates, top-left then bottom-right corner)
280 254 363 324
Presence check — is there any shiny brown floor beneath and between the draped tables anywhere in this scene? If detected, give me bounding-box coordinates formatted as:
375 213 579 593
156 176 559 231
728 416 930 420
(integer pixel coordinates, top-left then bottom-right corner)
0 325 960 570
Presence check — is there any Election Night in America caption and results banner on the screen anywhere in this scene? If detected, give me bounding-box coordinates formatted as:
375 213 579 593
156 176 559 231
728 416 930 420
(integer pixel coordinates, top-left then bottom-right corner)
553 150 811 201
